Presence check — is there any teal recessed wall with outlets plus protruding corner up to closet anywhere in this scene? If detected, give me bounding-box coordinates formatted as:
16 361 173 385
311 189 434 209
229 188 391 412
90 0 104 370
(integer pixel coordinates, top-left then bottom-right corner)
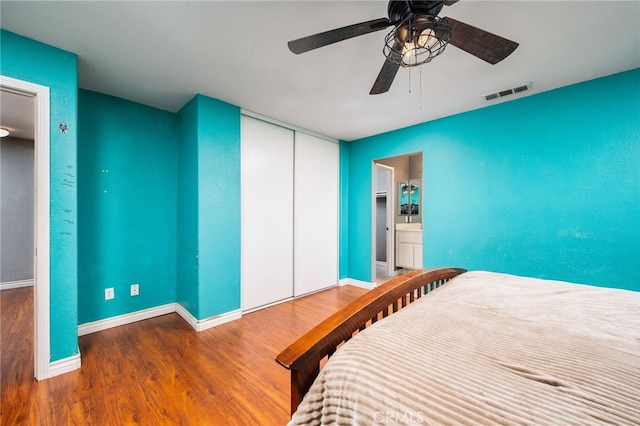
78 90 240 324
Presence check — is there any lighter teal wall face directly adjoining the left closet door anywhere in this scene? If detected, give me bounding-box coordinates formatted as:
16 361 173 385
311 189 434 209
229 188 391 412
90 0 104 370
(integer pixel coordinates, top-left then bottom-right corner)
196 95 240 319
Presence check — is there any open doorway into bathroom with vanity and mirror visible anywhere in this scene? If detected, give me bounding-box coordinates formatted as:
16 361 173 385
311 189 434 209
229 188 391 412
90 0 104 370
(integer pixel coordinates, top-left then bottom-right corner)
371 153 423 285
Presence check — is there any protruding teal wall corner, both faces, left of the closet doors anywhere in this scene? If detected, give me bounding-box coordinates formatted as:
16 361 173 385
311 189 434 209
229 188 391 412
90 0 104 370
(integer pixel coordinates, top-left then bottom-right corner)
178 95 240 320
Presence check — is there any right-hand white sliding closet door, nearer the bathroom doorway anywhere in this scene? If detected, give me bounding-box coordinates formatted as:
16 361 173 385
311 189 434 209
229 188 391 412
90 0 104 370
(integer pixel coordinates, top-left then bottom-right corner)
293 132 339 296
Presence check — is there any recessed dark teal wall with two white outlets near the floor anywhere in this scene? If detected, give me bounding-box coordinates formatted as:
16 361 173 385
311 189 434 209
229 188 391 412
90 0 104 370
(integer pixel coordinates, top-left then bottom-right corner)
78 90 177 324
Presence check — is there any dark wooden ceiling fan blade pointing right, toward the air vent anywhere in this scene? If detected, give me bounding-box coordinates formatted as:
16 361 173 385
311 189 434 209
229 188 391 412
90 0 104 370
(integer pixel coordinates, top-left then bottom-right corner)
444 17 518 65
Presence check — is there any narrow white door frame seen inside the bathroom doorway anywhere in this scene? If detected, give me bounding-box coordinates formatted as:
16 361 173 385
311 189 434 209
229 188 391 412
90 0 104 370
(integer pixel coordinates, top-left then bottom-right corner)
371 161 395 282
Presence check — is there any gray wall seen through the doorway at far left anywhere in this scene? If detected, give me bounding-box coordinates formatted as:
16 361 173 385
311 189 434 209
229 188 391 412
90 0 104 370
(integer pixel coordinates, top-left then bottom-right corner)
0 137 34 283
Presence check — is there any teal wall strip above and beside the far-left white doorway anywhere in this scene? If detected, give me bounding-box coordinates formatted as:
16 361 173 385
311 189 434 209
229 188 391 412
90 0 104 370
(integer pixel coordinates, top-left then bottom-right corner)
0 30 78 361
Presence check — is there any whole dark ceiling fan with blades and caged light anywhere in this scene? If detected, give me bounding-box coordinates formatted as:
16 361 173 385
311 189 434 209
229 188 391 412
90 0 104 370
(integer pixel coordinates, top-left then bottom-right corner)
288 0 518 95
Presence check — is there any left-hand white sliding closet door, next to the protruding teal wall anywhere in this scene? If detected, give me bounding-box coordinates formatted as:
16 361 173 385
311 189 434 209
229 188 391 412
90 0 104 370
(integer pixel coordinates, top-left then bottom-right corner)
241 116 294 311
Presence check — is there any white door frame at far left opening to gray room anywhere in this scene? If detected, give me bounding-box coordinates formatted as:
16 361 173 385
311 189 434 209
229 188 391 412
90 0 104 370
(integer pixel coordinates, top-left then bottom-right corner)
0 75 51 380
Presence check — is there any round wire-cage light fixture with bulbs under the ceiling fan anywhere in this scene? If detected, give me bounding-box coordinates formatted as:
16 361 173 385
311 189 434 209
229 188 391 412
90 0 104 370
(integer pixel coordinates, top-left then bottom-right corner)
383 15 451 67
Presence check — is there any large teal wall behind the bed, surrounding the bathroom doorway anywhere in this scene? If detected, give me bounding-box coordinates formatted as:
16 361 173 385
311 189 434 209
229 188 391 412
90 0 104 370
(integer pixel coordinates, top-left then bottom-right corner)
347 70 640 290
